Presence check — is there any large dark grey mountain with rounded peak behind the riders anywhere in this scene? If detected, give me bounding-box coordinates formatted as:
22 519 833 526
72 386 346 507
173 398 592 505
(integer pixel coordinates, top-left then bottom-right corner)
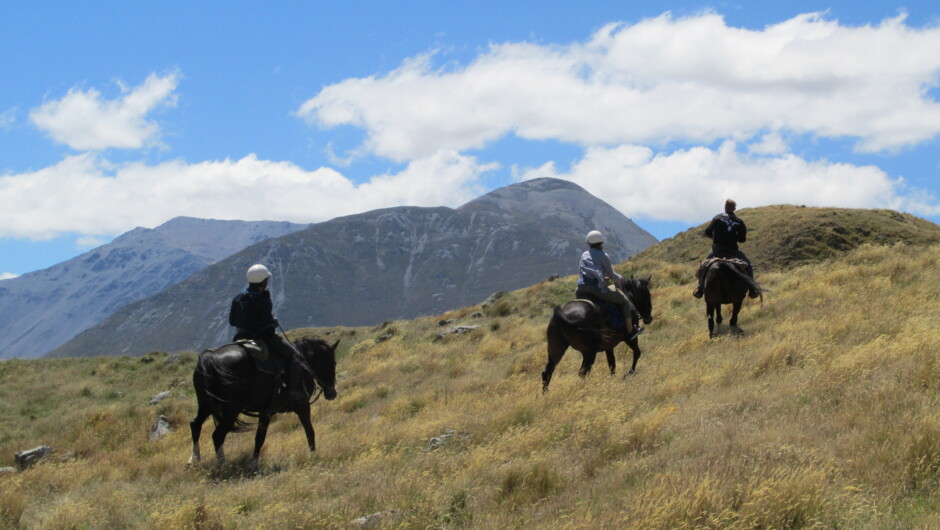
51 179 656 356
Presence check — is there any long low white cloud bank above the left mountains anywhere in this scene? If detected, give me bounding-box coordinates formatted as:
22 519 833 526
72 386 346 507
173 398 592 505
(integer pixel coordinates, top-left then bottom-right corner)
0 151 497 239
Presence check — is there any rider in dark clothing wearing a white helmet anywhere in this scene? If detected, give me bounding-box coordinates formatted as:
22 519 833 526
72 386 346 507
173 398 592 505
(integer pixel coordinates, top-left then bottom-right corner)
228 264 307 401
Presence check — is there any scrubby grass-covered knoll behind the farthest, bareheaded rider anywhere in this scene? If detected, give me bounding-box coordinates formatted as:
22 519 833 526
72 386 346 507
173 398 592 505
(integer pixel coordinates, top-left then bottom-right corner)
633 205 940 271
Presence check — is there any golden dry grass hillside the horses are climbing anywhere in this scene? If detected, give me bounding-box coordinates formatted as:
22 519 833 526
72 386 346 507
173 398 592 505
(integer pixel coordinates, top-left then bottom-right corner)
0 209 940 529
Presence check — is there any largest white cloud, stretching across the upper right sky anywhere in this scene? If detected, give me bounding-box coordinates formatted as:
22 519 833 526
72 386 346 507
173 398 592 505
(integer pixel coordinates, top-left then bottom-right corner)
297 14 940 160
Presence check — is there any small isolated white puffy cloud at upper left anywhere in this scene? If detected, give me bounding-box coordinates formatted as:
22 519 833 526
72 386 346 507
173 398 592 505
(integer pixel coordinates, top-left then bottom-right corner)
29 73 179 151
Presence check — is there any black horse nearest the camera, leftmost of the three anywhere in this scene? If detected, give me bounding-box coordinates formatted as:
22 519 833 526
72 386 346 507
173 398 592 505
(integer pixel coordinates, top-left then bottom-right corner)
189 339 339 467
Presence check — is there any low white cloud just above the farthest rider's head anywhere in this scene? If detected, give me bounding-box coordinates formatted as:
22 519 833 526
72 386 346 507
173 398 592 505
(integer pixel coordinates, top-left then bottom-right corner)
521 141 940 222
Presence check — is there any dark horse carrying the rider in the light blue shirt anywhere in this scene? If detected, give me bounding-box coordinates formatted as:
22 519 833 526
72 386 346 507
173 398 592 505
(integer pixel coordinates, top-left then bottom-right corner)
542 275 653 392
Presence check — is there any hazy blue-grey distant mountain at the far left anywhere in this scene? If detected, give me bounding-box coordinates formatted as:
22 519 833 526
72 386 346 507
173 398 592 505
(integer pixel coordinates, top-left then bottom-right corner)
0 217 306 358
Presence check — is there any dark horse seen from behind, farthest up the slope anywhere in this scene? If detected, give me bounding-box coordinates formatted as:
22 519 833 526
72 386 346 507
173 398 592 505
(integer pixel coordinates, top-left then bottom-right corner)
702 259 764 338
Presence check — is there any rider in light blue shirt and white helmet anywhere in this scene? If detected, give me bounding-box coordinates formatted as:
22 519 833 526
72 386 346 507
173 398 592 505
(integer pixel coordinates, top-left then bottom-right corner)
575 230 643 340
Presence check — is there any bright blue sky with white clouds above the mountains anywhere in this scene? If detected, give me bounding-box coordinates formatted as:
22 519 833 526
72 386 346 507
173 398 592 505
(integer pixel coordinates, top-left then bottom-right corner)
0 1 940 277
